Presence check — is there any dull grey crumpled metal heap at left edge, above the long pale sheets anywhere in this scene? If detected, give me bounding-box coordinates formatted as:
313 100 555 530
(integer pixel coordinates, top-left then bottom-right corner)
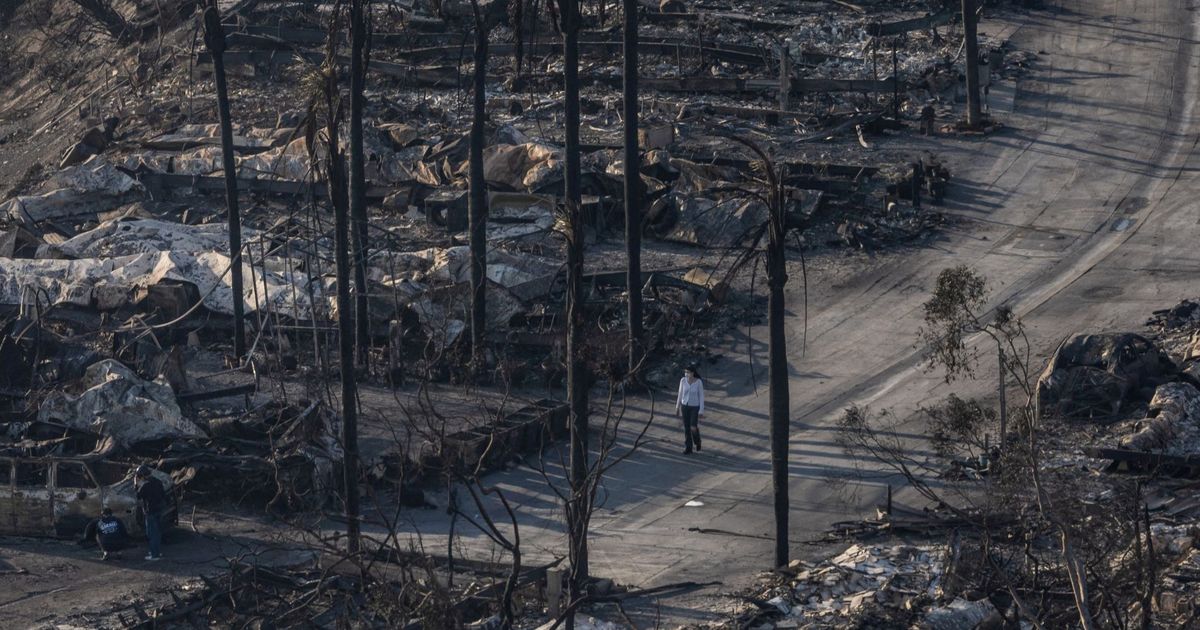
0 157 145 224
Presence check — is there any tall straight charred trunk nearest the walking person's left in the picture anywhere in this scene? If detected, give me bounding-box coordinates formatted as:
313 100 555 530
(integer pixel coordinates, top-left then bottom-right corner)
623 0 644 376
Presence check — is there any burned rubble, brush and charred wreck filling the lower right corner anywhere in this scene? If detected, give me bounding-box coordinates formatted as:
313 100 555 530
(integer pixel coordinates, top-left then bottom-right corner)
720 296 1200 629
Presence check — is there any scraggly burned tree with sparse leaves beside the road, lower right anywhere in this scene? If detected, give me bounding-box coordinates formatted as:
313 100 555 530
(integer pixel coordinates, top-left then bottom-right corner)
839 268 1159 628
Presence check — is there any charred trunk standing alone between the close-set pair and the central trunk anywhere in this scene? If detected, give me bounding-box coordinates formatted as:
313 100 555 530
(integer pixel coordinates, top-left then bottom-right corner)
468 0 488 372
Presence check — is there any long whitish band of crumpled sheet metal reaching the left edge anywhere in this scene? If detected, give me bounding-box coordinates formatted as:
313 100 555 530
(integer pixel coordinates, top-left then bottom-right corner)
0 251 312 319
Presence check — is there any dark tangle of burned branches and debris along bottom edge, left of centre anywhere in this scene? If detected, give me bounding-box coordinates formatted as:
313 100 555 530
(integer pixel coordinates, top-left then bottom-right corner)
130 547 566 630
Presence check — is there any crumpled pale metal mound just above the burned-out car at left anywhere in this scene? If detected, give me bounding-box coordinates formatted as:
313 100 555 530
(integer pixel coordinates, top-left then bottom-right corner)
37 359 204 445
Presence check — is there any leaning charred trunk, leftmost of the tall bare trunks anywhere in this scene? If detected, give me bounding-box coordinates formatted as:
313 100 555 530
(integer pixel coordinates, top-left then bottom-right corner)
204 6 246 362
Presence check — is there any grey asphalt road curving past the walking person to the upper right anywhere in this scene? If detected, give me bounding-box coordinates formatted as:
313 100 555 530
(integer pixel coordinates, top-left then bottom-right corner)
386 0 1200 620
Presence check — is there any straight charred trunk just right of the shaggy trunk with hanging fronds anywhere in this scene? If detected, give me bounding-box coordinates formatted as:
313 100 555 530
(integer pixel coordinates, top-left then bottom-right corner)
349 0 371 366
